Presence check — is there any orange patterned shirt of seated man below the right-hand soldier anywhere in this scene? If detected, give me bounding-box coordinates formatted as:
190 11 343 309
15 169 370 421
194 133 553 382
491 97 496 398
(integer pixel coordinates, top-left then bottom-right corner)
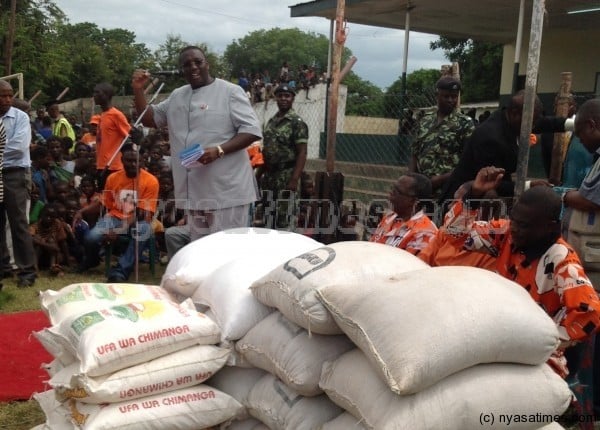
369 211 437 255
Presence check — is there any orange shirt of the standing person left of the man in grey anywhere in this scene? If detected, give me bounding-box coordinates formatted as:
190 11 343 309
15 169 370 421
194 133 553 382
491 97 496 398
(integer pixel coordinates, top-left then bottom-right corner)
96 107 131 170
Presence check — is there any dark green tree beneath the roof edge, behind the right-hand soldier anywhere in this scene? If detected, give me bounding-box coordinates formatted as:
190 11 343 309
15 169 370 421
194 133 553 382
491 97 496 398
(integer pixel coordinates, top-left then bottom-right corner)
430 36 502 102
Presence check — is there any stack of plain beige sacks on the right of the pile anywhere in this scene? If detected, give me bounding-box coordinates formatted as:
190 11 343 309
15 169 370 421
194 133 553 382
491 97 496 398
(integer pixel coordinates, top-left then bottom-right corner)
236 242 572 430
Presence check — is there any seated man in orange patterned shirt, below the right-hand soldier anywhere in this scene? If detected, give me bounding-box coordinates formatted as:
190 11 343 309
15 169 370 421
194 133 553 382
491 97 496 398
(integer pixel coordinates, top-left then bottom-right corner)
369 173 437 255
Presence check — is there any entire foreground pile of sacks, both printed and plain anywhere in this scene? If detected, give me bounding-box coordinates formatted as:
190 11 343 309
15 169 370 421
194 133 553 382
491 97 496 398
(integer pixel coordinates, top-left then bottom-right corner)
30 229 571 430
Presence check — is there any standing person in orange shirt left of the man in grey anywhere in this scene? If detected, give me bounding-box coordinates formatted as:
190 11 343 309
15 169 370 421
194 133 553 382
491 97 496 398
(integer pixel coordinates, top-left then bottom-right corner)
94 82 131 190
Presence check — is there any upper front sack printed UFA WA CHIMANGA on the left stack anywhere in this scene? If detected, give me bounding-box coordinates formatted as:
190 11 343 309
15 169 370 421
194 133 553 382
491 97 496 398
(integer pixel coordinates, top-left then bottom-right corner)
35 300 220 376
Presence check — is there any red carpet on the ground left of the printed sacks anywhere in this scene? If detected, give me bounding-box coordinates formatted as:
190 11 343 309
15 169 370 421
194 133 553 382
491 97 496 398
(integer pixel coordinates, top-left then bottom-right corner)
0 311 52 402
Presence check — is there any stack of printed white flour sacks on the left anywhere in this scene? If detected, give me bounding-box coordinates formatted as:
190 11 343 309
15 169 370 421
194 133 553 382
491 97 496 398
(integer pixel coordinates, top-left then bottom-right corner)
34 283 243 430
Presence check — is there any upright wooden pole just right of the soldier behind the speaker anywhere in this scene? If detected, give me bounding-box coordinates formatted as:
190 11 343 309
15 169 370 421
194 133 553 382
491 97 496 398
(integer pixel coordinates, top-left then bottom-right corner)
325 0 346 173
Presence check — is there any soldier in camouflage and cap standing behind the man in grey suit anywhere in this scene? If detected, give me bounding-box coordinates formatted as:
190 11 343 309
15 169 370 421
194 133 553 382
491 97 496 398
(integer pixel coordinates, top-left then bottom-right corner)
257 84 308 229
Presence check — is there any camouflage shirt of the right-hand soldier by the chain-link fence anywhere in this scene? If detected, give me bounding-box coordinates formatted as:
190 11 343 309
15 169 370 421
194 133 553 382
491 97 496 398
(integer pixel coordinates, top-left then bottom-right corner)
411 110 475 178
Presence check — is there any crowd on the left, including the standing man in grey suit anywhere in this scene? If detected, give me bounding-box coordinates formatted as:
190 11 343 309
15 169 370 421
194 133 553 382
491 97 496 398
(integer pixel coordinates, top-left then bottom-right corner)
0 50 317 287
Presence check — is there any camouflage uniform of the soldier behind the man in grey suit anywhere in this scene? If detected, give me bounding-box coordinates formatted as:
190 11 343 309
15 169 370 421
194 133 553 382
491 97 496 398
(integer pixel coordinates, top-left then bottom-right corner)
260 109 308 227
